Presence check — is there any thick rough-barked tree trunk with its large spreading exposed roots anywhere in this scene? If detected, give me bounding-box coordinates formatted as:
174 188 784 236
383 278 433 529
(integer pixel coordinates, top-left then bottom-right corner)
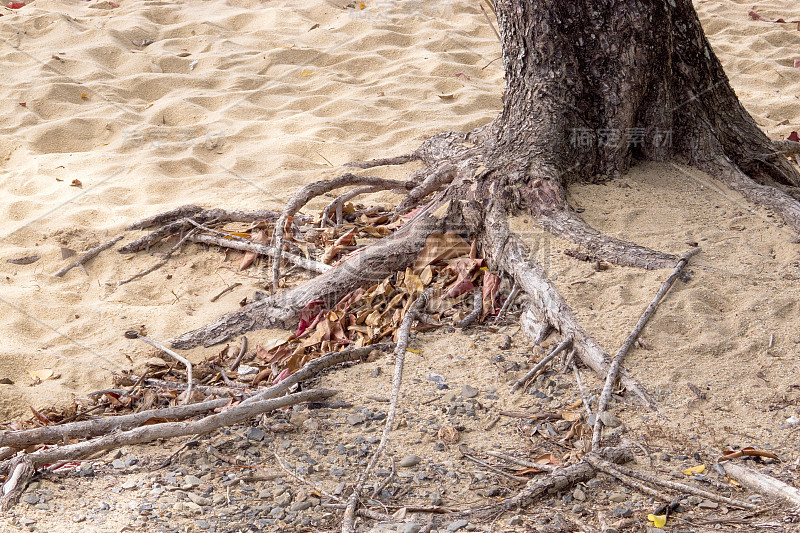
152 0 800 350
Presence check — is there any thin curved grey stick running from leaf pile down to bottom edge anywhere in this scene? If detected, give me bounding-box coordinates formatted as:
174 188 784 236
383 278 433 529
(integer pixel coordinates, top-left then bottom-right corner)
342 289 432 533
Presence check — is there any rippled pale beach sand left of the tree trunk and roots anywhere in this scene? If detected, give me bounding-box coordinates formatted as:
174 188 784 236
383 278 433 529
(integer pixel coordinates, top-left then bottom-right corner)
0 0 502 418
